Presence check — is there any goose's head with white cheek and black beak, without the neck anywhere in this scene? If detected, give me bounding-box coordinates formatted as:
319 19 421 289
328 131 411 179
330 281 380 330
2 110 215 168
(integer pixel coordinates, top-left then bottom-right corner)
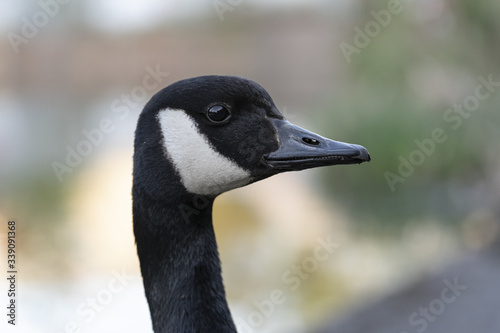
134 76 370 200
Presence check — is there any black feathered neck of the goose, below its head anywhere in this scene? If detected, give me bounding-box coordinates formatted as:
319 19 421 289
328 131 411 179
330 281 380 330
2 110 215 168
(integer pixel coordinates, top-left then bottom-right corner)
133 187 236 333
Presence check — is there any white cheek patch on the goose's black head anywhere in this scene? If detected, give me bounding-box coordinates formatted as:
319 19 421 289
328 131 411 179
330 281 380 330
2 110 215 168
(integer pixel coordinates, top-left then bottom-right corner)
158 109 251 195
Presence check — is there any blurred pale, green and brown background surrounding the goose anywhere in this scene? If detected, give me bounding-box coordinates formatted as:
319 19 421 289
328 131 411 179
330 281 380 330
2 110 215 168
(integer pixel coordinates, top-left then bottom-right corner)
0 0 500 332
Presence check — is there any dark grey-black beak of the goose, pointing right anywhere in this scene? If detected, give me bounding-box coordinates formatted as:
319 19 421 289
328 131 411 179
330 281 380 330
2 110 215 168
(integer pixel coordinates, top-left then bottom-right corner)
263 119 370 171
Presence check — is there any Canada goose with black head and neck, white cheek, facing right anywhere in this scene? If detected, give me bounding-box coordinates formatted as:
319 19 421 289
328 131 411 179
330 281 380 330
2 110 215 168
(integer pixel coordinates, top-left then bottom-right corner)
132 75 370 333
